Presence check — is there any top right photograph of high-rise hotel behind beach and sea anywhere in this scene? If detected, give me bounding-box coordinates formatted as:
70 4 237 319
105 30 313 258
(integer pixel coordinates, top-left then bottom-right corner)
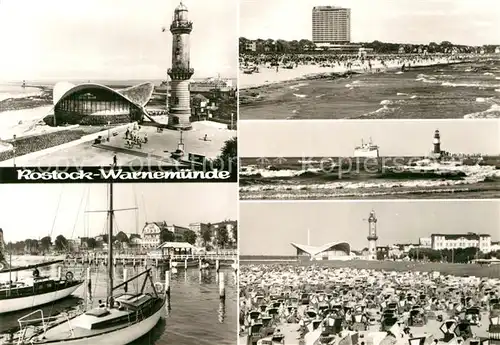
239 0 500 120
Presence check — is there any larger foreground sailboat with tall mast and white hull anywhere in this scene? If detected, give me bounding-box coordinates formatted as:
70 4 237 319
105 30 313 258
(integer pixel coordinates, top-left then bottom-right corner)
8 160 167 345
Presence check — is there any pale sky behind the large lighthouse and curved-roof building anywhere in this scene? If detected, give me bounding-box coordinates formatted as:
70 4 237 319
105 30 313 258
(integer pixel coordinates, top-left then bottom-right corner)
0 0 238 81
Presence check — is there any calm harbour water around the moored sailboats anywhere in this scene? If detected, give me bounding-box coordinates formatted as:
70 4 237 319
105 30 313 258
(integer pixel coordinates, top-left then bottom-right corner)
0 265 238 345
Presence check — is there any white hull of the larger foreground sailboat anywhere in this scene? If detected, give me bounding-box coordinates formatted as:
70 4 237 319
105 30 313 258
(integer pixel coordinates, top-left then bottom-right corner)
35 296 165 345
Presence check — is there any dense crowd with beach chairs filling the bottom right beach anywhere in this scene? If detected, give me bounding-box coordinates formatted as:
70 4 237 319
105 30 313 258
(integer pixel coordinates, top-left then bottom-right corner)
240 264 500 345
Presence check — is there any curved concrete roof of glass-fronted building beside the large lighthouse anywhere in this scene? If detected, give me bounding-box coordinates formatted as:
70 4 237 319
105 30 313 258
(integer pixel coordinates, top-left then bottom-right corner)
52 82 154 107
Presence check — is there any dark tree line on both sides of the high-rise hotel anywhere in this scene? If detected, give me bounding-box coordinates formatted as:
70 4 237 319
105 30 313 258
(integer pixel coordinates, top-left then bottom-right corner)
239 37 498 54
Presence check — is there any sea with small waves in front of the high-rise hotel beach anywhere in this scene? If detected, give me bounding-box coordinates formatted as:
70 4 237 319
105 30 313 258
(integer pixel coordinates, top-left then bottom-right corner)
240 59 500 120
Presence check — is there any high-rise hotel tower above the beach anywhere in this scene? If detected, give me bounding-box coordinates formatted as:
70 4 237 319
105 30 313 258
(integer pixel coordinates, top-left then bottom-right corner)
312 6 351 43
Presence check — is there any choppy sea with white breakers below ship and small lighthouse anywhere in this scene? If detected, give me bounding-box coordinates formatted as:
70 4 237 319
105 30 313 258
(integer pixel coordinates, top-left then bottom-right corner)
239 156 500 200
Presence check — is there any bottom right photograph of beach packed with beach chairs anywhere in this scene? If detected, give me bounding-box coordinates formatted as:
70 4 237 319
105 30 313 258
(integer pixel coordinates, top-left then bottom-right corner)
239 200 500 345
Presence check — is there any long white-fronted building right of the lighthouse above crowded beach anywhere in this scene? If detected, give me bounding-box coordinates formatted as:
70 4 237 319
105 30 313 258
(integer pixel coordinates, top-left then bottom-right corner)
431 232 491 253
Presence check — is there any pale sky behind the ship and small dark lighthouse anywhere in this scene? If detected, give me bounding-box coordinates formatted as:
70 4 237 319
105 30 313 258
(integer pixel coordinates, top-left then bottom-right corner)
239 120 500 157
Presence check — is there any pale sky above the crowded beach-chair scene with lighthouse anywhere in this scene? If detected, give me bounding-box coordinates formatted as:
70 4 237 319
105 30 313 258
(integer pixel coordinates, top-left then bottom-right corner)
239 200 500 255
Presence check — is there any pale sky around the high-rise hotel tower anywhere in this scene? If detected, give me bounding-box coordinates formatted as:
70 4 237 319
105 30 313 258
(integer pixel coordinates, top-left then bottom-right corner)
240 0 500 45
